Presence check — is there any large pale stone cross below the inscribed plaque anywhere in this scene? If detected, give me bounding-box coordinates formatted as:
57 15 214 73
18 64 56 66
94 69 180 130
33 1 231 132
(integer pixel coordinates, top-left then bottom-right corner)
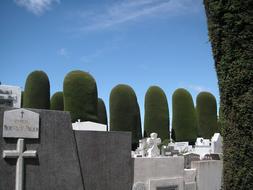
3 139 37 190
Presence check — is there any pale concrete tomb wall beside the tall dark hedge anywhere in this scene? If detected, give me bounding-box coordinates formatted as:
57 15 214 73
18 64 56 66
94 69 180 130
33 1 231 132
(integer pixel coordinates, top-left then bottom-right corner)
191 160 223 190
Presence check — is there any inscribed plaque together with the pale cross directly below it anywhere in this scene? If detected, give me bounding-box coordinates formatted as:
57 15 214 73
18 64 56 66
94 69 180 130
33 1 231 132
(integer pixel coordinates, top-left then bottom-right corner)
3 109 39 190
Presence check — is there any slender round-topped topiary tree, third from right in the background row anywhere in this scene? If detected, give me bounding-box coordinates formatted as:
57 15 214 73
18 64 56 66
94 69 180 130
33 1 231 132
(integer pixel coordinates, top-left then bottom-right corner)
144 86 170 141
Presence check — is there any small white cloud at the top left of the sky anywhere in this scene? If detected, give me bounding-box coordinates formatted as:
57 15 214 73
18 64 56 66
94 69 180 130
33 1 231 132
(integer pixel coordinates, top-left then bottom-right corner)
14 0 60 15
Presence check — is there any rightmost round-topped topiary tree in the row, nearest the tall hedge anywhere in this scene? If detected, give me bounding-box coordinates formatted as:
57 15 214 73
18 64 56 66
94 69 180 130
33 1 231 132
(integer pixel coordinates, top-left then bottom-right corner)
196 92 218 139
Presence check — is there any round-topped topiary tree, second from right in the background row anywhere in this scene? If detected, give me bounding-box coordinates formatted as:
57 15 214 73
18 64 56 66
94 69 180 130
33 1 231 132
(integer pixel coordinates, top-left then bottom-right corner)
172 88 197 144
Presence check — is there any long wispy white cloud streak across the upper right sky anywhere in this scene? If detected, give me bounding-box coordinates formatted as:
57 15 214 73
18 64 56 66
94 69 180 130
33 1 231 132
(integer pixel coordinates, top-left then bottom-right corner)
76 0 202 30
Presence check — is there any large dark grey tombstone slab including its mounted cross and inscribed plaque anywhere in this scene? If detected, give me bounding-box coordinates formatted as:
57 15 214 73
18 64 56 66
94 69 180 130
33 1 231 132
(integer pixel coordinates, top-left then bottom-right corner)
0 107 84 190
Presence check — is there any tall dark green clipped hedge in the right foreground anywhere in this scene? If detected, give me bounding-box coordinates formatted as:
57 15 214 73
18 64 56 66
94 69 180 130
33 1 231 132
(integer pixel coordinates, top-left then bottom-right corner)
204 0 253 190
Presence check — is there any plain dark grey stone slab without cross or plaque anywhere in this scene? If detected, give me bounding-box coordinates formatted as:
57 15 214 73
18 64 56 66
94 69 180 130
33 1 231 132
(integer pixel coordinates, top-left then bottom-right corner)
75 131 133 190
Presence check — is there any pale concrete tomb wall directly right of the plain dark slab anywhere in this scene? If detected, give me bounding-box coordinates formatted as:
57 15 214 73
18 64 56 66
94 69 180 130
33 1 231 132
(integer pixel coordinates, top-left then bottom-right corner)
133 156 184 190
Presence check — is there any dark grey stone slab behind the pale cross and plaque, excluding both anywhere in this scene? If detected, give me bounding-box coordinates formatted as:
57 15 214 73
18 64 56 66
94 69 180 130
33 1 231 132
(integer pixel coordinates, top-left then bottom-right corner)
0 108 84 190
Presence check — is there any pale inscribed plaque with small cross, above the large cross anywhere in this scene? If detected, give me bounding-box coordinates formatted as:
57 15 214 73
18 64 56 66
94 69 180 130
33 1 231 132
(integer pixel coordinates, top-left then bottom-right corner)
3 109 39 139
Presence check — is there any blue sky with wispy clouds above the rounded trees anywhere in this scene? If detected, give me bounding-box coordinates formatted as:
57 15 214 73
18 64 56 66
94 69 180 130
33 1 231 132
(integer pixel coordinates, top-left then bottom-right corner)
0 0 219 127
